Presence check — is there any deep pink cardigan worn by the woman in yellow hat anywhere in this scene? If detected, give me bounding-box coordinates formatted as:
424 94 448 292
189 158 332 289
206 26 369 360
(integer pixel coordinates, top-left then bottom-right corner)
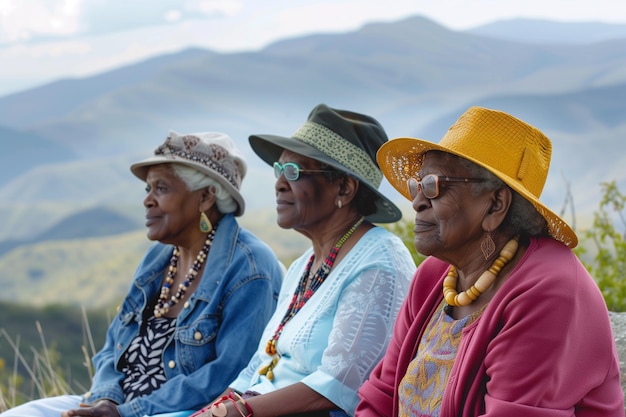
355 239 624 417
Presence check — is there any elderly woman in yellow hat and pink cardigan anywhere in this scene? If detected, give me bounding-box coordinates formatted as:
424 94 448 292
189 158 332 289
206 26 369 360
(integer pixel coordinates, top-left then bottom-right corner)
356 107 624 417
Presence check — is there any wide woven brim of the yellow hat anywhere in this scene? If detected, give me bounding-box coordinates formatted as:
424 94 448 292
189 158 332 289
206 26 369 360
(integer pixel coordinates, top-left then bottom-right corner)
376 138 578 248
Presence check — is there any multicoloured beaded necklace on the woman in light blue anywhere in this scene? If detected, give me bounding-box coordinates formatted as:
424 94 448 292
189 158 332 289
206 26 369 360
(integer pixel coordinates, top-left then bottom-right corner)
259 217 365 381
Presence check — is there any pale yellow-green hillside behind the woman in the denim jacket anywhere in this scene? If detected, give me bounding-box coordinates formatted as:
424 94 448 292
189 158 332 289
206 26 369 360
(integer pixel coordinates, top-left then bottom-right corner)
0 209 308 309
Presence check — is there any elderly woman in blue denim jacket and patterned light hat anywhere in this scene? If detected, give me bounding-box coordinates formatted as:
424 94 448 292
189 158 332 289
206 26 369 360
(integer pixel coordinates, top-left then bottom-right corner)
3 132 282 417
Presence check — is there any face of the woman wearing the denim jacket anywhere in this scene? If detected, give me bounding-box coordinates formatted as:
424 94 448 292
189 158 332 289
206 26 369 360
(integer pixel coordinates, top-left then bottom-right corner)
143 164 201 245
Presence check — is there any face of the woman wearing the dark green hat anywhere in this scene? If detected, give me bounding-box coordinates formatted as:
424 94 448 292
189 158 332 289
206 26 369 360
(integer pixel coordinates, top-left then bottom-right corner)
275 150 338 235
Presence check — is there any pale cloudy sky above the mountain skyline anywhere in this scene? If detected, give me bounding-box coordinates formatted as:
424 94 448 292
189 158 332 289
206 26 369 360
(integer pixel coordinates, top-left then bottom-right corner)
0 0 626 96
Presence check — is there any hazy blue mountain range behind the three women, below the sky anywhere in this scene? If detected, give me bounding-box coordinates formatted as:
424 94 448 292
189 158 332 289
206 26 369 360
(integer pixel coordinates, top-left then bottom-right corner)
0 16 626 306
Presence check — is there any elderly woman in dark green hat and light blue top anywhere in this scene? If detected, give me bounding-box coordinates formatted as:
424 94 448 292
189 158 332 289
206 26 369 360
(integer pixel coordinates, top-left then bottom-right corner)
189 105 415 417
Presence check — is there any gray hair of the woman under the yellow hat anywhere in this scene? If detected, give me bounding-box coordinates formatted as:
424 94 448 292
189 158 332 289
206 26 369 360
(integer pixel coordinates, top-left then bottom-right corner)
451 155 549 236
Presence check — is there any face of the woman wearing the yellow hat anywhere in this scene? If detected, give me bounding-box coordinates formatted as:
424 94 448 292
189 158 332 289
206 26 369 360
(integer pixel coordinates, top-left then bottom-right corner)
413 152 491 264
